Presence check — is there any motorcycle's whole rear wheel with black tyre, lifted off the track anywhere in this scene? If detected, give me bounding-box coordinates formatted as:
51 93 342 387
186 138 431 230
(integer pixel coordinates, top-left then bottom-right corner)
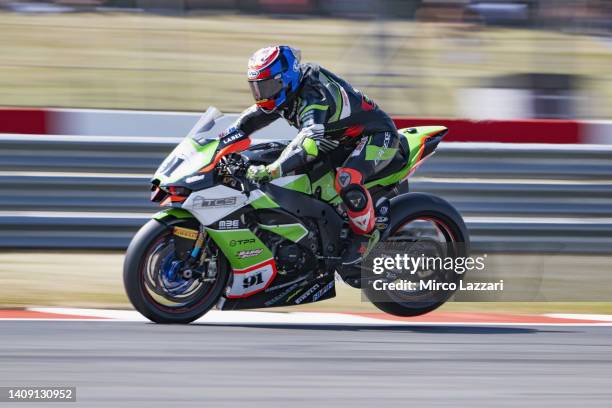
363 193 469 316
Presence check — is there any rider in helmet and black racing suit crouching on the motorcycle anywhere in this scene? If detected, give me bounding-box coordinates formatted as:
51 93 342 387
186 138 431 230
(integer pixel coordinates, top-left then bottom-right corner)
224 45 399 260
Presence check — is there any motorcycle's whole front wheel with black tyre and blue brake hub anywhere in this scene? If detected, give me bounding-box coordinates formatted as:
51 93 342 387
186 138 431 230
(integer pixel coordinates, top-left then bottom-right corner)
123 220 229 324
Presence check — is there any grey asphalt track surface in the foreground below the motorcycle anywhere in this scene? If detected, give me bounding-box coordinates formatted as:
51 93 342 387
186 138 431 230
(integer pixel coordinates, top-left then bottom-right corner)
0 321 612 408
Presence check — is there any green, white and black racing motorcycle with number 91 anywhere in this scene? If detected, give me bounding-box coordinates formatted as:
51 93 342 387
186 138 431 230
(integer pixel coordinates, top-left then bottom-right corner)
123 108 469 323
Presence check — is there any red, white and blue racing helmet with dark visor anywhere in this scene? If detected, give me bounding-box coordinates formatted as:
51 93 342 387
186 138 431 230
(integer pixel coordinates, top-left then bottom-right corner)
247 45 301 112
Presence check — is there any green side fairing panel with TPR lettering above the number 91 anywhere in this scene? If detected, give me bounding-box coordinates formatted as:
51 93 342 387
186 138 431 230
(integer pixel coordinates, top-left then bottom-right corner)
206 228 272 269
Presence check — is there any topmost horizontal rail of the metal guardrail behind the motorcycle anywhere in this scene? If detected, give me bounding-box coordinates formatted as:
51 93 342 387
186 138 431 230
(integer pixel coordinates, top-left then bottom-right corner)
5 135 612 180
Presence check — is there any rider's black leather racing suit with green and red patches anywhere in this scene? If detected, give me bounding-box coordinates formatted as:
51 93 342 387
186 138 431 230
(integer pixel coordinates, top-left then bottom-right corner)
228 64 399 234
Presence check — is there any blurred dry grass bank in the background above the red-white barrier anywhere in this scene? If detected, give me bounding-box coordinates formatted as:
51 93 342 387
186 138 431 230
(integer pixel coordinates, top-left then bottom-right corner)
0 13 612 118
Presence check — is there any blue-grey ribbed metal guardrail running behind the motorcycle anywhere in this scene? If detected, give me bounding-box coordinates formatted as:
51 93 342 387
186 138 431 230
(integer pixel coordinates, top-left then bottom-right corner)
0 135 612 253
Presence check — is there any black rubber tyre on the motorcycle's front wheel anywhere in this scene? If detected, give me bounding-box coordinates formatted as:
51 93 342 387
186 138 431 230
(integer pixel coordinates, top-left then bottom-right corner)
123 220 229 324
